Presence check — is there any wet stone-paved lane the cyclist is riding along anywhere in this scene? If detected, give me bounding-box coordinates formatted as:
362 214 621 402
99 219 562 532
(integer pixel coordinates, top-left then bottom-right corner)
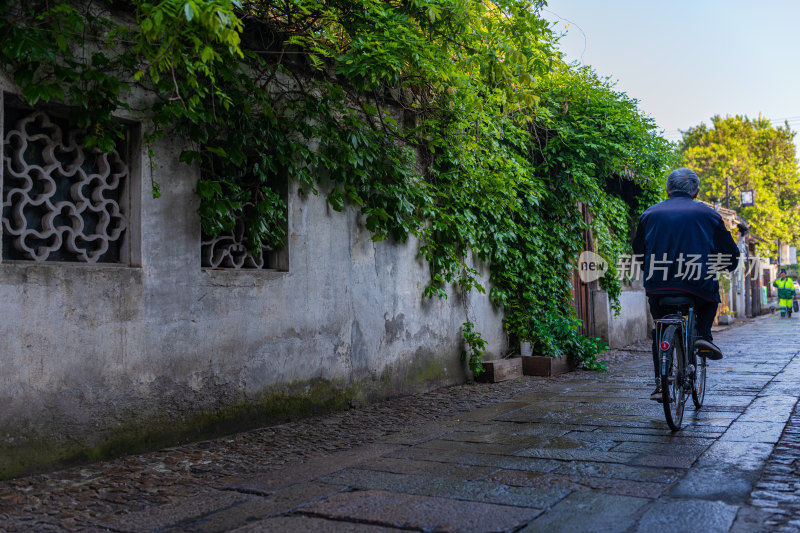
0 316 800 533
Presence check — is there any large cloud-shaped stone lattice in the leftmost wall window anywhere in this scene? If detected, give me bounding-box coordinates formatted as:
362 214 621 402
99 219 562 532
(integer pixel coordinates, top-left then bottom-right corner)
3 111 128 263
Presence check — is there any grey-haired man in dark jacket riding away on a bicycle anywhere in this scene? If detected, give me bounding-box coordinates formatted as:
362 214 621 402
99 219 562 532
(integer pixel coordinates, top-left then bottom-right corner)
633 168 739 401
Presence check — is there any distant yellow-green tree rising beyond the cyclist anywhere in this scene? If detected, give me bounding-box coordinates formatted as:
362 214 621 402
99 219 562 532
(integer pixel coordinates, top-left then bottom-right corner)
680 115 800 256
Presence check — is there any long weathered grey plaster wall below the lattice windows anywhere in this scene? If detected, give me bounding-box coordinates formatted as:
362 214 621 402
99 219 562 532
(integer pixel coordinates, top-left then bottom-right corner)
0 72 506 475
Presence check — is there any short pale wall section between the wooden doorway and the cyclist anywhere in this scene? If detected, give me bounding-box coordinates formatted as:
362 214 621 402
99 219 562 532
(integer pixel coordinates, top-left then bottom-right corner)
593 289 651 348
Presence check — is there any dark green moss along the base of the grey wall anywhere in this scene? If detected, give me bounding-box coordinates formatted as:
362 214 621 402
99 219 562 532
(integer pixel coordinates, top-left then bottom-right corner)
0 357 452 479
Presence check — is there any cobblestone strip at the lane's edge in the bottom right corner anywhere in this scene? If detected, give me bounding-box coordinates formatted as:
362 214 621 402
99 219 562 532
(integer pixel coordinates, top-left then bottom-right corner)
749 403 800 533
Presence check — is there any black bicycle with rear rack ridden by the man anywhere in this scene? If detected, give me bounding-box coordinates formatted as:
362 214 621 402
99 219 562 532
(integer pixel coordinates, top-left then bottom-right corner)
654 296 706 431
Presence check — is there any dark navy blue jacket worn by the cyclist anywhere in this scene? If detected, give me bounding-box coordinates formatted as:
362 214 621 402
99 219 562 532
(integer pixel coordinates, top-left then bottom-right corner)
633 192 739 302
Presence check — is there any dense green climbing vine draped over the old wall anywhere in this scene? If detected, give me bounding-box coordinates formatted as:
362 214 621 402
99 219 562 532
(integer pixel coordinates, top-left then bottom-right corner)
0 0 674 372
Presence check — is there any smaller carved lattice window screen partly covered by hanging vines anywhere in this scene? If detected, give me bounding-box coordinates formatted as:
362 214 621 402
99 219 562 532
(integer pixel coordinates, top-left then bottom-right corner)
201 204 285 270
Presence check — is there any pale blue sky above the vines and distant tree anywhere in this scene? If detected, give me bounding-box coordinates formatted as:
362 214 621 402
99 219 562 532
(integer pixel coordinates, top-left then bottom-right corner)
542 0 800 144
